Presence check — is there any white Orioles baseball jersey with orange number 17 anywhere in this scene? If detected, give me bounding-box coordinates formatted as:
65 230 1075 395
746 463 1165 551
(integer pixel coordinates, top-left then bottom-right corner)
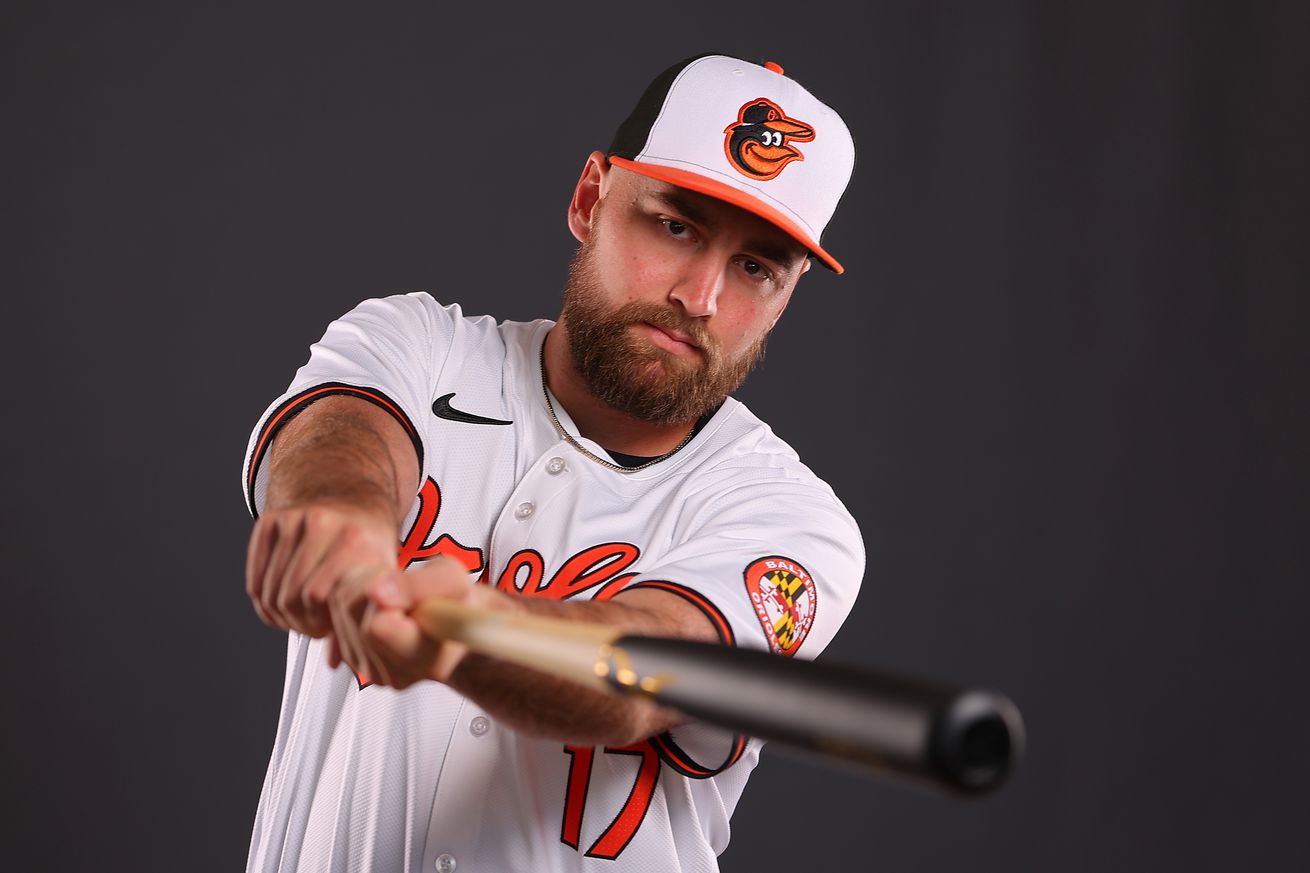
244 294 865 873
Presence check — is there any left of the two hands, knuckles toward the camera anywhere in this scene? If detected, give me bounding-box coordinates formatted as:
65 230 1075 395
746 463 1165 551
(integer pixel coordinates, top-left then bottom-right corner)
246 502 400 637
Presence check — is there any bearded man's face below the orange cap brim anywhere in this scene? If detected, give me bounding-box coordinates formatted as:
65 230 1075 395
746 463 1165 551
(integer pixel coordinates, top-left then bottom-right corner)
563 163 806 425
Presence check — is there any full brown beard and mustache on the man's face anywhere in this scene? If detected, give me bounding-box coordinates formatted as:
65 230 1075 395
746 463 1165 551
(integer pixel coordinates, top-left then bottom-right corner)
563 234 769 425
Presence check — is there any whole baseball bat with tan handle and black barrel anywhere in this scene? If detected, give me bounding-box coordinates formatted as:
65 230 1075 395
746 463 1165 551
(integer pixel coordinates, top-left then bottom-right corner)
414 599 1023 794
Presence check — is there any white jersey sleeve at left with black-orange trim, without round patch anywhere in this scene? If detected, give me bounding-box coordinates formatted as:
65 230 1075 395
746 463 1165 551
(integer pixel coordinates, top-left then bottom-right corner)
241 292 461 515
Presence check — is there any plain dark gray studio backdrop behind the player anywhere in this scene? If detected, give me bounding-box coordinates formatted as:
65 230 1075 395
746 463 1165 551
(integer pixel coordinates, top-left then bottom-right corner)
0 0 1310 872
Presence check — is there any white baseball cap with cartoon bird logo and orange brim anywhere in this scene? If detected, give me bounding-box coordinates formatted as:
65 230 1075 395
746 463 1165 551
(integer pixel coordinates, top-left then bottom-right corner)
609 55 855 273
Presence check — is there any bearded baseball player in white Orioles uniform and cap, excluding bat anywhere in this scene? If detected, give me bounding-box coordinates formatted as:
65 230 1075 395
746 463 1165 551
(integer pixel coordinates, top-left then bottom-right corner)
242 55 863 873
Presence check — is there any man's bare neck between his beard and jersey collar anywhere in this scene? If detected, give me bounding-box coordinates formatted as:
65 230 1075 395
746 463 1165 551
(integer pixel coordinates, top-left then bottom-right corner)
545 319 696 457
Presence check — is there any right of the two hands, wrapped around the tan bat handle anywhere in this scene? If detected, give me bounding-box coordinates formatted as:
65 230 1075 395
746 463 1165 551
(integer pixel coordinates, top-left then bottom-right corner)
348 557 487 688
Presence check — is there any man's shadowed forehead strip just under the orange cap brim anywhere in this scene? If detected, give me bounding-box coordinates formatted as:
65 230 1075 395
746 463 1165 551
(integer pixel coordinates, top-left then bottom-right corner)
607 166 810 262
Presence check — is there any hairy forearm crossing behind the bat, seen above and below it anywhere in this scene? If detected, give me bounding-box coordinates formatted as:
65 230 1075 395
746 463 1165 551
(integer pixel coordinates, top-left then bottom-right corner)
447 591 714 746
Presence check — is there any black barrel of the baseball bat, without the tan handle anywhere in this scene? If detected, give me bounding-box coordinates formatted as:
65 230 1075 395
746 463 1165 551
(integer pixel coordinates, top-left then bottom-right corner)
609 637 1023 794
